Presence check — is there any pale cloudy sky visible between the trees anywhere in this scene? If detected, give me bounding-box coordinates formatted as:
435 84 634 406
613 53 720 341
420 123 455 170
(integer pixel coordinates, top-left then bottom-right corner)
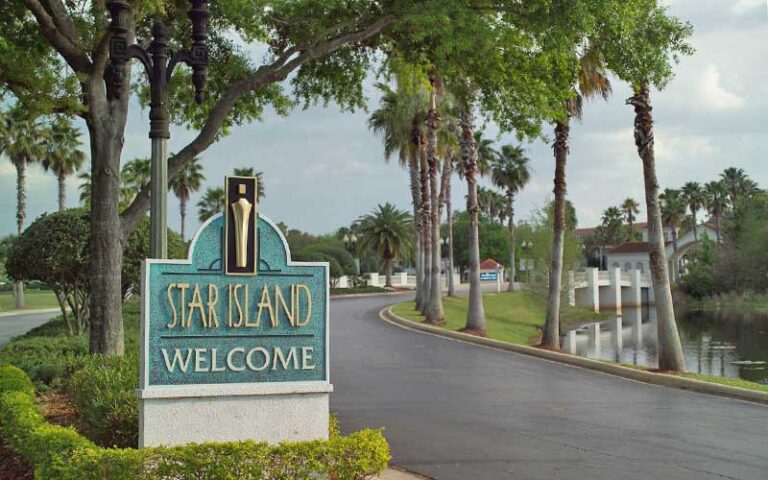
0 0 768 235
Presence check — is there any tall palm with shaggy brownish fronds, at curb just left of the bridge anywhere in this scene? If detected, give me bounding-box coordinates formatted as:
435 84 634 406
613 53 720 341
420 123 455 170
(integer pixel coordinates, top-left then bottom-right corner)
542 48 611 348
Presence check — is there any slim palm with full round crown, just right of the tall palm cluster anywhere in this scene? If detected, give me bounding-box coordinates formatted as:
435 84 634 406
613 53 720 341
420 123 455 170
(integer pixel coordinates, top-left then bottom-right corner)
491 145 531 292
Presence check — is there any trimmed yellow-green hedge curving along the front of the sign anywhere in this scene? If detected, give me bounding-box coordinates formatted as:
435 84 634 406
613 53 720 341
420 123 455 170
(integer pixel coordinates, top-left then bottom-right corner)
0 366 390 480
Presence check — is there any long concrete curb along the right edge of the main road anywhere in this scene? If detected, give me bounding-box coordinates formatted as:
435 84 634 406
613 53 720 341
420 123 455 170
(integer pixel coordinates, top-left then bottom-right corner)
379 305 768 405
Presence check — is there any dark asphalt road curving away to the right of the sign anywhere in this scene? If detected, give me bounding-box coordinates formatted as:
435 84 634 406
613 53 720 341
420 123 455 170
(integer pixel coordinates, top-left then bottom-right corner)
331 296 768 480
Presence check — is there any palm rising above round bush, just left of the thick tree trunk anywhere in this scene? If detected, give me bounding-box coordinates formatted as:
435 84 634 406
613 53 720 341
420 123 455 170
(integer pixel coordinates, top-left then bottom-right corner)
42 119 85 211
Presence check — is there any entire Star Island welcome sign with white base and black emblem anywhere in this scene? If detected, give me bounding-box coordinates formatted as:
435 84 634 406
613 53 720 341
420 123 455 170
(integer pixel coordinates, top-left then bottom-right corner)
137 177 333 447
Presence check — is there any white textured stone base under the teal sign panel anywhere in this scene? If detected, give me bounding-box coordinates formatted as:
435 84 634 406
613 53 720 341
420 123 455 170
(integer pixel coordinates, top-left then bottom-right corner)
136 382 333 448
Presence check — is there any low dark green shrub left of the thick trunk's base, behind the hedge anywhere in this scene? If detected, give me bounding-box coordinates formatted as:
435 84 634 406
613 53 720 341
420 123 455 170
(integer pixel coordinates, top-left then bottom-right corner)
0 336 88 386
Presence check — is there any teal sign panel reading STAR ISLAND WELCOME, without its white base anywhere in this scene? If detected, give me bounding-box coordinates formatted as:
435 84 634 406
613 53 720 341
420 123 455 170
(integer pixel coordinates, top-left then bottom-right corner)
142 213 328 388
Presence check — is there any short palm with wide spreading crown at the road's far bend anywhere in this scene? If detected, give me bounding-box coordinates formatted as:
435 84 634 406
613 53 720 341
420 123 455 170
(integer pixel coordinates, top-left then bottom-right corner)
358 203 413 287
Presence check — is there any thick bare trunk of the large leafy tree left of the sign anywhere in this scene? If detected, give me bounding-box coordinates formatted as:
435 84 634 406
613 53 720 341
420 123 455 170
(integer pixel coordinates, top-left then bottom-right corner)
86 80 128 355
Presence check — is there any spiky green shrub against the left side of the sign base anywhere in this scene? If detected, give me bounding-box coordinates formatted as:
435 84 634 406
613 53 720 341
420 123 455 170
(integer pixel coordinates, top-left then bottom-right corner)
69 355 139 447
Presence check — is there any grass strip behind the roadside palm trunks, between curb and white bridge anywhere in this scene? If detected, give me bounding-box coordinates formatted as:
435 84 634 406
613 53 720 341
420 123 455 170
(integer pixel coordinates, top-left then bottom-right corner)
392 292 605 345
